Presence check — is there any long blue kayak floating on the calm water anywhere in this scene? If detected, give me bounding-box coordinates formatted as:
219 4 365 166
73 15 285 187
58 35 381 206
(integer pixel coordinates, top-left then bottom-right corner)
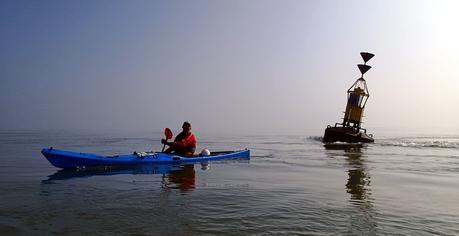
41 148 250 169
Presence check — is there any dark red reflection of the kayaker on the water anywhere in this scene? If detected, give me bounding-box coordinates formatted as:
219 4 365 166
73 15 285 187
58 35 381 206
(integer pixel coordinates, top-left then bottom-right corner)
163 165 196 192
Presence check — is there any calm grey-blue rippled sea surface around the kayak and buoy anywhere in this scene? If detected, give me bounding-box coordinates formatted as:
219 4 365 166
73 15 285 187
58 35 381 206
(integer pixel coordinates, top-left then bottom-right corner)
0 131 459 235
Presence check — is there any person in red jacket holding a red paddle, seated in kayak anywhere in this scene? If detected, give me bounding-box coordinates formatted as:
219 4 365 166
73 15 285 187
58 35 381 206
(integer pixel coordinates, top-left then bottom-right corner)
161 121 197 156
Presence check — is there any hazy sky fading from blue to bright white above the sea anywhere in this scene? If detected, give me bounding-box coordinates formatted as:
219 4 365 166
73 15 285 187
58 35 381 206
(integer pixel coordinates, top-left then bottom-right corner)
0 0 459 132
